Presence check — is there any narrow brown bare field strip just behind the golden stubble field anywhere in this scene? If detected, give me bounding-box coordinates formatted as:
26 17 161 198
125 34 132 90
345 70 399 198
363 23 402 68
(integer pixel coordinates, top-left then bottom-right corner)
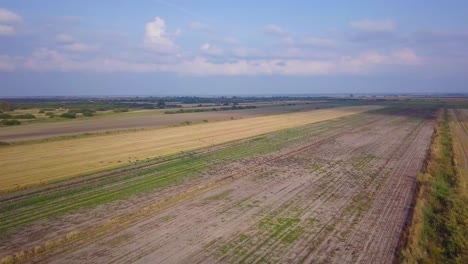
0 104 336 142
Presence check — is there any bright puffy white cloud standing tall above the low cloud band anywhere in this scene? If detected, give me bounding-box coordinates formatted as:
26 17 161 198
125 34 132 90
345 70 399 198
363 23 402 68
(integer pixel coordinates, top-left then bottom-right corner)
144 17 177 53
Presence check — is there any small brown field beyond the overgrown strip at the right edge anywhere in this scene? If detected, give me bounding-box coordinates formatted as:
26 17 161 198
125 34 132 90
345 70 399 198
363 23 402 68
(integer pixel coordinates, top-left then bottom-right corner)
449 109 468 195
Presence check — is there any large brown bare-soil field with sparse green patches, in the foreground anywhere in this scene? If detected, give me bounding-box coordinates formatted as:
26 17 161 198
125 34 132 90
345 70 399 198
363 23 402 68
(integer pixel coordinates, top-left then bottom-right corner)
0 108 433 263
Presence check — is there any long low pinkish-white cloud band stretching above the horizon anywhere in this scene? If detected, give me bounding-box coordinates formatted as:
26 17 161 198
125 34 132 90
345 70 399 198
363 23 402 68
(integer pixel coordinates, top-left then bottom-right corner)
20 49 420 76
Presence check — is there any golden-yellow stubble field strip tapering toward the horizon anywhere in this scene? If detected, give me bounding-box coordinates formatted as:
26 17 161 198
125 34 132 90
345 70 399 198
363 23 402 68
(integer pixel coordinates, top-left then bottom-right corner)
0 106 380 191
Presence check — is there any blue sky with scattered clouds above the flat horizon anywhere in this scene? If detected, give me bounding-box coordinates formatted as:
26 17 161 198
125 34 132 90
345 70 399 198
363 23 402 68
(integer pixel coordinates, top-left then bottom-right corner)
0 0 468 97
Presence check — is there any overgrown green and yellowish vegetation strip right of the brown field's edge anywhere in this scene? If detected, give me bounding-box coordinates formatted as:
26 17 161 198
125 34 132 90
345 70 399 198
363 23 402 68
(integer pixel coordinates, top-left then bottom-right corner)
400 109 468 263
